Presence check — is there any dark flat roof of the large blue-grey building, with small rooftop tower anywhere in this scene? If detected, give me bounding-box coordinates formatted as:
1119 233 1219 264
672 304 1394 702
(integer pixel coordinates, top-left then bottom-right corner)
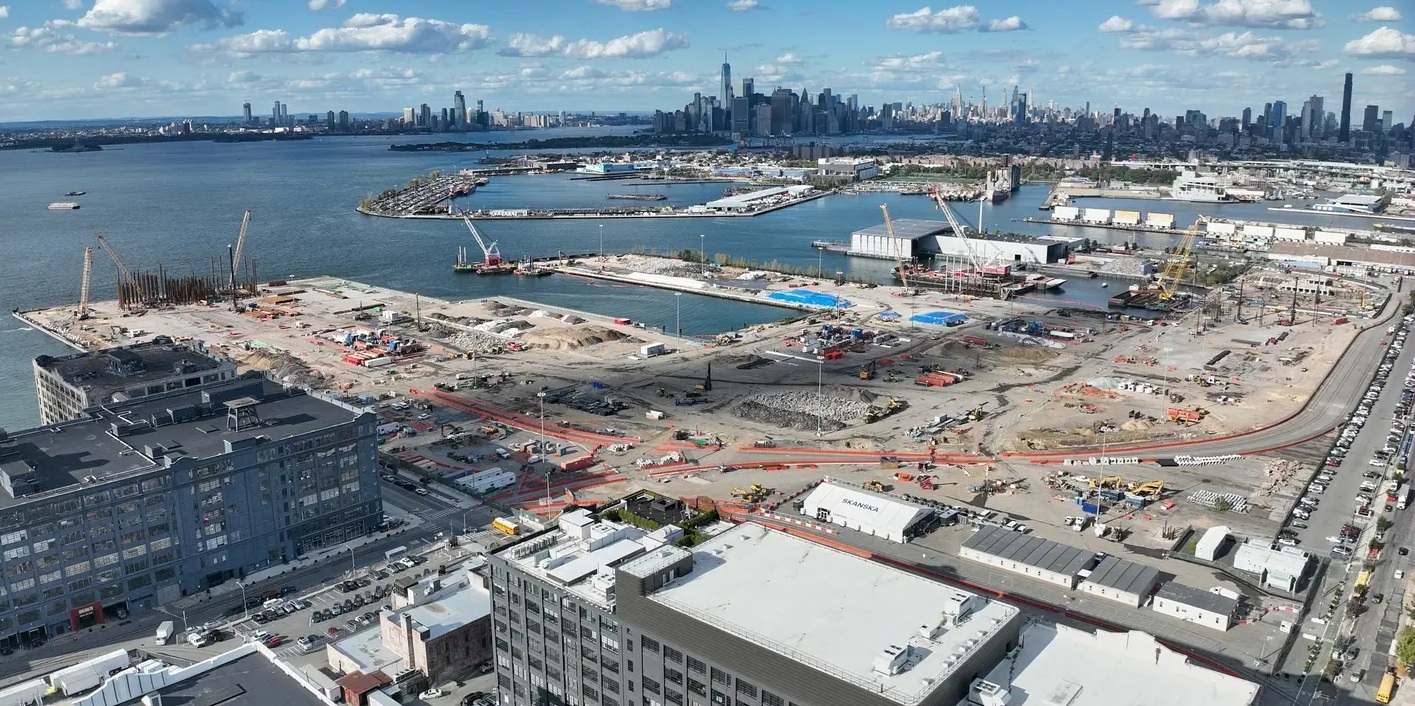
0 378 361 507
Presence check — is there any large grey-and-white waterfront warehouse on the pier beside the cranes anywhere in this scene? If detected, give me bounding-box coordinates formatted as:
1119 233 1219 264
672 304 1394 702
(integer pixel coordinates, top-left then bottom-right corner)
848 218 1081 266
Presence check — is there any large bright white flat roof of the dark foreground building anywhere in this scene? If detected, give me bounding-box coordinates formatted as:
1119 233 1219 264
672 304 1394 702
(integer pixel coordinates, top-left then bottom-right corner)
625 522 1019 703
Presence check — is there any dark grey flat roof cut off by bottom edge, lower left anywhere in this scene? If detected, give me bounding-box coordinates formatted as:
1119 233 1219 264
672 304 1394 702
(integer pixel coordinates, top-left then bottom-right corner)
154 652 324 706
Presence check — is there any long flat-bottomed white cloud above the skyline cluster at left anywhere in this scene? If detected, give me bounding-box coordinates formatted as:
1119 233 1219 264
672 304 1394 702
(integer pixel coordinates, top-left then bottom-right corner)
190 13 491 54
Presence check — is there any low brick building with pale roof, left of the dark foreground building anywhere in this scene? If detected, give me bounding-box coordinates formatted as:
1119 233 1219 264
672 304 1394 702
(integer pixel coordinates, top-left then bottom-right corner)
325 571 491 685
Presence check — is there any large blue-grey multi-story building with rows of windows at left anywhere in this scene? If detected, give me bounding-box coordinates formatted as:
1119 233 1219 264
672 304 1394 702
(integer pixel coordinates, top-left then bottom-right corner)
0 374 382 641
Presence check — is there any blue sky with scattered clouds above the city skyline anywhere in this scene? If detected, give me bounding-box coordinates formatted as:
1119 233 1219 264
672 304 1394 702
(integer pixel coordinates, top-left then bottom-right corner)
0 0 1415 122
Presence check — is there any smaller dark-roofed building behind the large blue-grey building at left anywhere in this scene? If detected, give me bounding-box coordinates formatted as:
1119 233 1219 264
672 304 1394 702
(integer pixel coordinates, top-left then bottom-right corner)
34 337 236 424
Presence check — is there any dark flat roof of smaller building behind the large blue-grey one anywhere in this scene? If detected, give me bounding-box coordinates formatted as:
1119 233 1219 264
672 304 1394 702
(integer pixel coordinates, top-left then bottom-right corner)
34 342 235 402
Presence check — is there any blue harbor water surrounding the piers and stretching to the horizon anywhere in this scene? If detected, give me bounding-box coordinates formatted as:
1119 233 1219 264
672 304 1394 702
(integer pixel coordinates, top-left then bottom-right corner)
0 130 1392 429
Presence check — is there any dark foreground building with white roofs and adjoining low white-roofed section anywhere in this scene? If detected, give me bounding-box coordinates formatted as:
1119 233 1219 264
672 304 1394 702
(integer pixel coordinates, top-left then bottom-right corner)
488 509 1257 706
